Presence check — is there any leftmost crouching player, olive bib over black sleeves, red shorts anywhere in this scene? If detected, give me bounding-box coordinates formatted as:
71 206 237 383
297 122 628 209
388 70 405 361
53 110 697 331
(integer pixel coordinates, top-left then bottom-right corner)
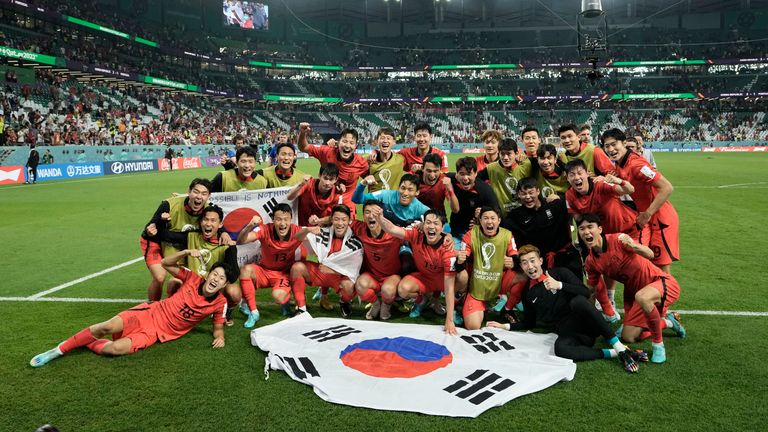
140 178 211 301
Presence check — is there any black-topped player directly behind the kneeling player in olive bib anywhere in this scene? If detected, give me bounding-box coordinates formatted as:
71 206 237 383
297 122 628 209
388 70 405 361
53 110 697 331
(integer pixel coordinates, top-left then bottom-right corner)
448 157 499 250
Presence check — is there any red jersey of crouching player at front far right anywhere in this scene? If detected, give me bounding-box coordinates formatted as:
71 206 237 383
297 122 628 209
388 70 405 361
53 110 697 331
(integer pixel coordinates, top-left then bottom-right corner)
584 234 668 298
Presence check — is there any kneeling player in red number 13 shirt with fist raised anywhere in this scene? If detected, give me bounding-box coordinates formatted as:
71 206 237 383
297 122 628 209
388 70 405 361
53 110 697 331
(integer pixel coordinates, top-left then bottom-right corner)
237 203 309 328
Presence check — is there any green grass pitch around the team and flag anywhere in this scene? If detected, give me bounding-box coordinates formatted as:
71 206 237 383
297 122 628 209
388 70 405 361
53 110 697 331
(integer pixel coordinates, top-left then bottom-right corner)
0 153 768 431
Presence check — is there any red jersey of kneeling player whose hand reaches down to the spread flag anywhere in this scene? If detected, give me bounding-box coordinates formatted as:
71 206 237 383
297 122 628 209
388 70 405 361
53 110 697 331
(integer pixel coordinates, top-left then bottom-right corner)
405 228 456 286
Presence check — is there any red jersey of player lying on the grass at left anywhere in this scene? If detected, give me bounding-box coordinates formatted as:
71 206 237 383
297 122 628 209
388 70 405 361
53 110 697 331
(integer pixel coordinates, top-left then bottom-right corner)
151 267 227 342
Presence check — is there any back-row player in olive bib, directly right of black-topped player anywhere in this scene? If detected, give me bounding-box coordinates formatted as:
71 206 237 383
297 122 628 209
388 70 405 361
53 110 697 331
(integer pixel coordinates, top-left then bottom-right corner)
477 138 531 216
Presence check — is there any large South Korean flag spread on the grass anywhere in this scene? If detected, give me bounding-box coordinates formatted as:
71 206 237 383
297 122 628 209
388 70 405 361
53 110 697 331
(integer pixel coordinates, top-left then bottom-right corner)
251 313 576 417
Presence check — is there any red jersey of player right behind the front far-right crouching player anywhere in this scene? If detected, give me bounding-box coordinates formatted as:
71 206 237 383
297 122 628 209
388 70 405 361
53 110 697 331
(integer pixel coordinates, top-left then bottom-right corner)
565 181 637 234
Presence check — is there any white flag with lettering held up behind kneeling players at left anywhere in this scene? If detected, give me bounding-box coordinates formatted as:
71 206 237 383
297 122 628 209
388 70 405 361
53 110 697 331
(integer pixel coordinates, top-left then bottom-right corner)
208 186 301 266
